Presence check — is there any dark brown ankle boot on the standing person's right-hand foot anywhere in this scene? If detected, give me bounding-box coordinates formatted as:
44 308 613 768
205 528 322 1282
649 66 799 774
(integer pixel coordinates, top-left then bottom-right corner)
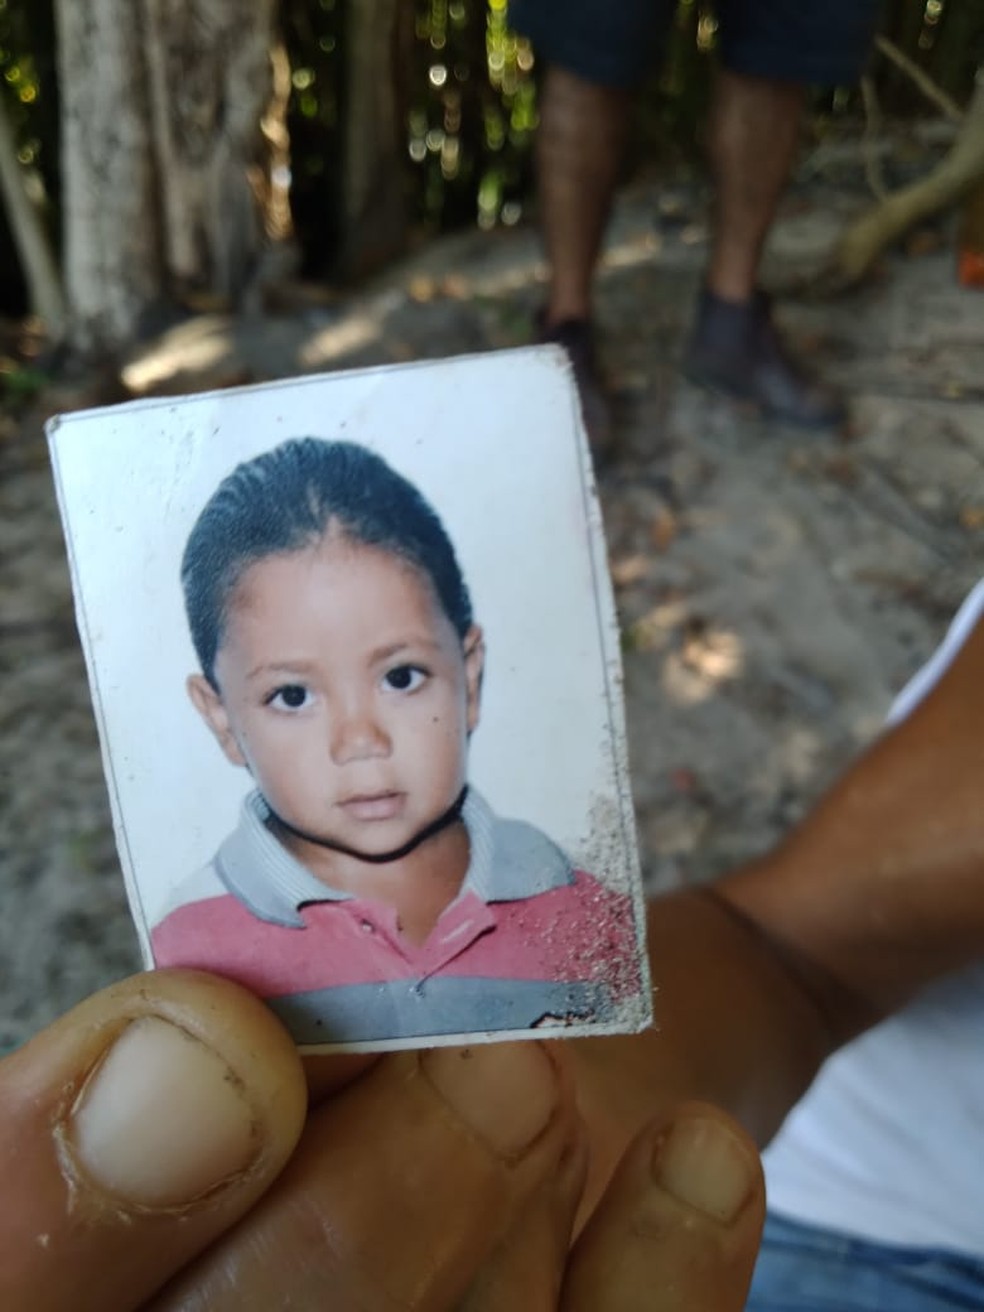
682 289 848 429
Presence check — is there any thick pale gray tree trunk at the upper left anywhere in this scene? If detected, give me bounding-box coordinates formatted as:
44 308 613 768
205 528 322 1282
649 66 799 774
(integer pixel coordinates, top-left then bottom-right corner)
55 0 273 354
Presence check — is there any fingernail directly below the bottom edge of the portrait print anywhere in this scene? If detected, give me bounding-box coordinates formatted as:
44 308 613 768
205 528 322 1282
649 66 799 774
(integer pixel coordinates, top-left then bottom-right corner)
421 1043 560 1157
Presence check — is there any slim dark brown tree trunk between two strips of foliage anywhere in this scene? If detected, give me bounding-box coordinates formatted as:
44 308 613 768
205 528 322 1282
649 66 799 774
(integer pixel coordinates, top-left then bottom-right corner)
338 0 413 278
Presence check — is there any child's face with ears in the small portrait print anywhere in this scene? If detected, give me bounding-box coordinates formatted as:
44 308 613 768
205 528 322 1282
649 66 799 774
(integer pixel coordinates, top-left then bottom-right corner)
189 538 483 855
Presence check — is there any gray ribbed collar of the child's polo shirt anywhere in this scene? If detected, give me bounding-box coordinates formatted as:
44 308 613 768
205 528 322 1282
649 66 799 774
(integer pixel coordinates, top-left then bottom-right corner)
214 787 573 928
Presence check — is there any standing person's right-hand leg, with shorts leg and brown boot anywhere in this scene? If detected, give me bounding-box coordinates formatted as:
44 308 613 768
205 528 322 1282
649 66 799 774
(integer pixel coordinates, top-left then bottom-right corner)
684 0 878 428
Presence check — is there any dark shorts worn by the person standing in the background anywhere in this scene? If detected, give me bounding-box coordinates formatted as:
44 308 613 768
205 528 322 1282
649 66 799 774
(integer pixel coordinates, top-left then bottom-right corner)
509 0 882 88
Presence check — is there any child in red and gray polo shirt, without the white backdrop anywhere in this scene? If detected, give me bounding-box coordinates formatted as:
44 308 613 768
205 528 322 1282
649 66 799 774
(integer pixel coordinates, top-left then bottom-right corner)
151 438 639 1043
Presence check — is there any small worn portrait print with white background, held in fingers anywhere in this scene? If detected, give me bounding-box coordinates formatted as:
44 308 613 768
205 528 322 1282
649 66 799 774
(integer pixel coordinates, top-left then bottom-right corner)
49 348 651 1051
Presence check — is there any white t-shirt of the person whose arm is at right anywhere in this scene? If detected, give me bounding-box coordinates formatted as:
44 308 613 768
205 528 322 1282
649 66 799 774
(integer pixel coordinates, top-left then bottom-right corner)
765 580 984 1258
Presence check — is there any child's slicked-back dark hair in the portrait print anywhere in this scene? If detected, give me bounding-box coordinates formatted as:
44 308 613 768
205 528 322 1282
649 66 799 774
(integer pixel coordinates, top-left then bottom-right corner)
181 437 472 686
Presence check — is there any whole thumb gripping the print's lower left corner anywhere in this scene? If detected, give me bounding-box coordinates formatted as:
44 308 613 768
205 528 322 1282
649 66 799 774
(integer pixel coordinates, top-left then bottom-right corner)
0 971 306 1312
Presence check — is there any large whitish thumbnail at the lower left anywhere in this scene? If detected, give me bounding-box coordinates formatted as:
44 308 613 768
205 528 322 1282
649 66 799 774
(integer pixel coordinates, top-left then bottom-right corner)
62 1017 260 1208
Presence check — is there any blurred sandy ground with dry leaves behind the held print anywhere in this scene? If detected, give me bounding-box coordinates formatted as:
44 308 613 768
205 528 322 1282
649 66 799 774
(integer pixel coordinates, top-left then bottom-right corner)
0 164 984 1050
